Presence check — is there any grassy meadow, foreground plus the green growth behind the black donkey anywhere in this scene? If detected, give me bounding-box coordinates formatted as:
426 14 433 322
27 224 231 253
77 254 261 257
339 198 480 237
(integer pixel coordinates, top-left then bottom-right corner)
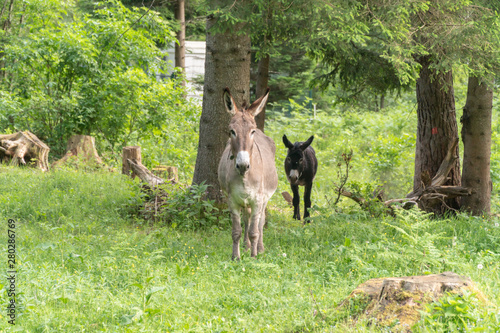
0 96 500 332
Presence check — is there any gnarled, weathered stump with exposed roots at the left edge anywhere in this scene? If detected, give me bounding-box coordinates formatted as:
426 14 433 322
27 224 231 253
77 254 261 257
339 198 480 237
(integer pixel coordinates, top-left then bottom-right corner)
0 131 50 171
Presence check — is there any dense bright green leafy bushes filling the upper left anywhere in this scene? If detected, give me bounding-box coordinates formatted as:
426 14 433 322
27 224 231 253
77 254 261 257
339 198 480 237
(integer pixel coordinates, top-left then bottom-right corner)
0 1 196 156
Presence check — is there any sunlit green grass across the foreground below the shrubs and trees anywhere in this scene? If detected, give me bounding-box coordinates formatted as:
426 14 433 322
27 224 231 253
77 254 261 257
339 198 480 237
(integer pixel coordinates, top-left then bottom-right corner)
0 167 500 332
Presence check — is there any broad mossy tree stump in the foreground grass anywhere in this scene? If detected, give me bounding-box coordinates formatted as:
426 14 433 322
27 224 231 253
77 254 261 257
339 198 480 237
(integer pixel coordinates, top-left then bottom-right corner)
339 272 477 332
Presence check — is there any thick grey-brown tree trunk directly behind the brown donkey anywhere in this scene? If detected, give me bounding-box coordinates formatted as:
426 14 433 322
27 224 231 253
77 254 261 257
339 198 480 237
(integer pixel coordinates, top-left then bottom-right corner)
193 17 250 202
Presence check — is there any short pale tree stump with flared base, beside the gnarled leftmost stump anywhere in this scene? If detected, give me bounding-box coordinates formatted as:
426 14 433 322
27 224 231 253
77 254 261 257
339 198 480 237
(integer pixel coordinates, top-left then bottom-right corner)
52 135 102 168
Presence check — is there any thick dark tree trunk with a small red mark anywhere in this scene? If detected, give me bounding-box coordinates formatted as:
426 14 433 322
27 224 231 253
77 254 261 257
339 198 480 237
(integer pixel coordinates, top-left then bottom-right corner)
413 57 460 213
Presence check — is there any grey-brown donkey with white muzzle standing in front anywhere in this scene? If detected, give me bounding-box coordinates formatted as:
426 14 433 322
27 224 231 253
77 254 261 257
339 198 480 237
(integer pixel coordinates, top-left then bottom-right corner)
219 88 278 259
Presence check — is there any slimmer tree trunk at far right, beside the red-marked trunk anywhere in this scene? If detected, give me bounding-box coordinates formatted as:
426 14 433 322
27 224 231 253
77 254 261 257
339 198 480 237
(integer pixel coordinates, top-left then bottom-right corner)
461 77 493 216
